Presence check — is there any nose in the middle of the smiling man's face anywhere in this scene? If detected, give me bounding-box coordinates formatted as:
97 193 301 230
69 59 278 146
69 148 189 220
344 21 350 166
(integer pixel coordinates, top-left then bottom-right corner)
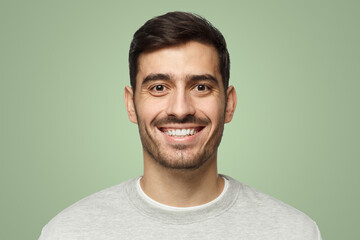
166 90 195 119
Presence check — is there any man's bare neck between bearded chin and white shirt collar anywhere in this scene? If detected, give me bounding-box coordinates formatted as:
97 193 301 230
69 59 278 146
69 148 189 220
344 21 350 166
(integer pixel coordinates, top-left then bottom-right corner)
140 153 224 207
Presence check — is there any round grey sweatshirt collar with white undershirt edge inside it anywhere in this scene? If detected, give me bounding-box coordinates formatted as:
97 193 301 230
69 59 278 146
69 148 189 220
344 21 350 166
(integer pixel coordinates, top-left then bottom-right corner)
127 175 241 224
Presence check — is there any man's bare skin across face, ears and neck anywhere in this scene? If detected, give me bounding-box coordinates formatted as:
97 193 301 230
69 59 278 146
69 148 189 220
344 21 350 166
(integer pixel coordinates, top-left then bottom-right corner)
124 41 237 207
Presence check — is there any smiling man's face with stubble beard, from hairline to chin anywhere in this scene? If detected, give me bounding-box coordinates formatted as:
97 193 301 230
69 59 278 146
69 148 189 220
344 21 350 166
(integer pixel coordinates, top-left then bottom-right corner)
127 42 236 169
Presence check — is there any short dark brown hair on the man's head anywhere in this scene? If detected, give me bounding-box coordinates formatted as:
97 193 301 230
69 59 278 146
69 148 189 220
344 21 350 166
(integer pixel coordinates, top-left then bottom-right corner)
129 11 230 94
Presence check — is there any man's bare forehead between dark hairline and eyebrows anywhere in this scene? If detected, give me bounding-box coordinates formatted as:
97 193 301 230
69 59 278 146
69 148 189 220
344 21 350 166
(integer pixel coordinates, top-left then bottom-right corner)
136 41 221 84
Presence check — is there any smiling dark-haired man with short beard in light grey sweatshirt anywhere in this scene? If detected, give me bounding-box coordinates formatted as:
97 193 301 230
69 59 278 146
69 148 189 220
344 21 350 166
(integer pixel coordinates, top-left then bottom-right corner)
40 12 321 240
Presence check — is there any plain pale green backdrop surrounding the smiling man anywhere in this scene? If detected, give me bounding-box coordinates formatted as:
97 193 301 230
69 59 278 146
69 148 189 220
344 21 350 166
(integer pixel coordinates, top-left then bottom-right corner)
0 0 360 240
